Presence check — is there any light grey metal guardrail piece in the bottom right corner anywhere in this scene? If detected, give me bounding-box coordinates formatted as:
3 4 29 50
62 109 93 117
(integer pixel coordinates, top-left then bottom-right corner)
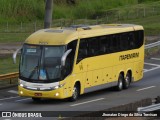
137 103 160 113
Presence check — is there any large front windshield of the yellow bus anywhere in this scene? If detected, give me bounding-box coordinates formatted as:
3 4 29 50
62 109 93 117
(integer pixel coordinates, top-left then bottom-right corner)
20 45 65 82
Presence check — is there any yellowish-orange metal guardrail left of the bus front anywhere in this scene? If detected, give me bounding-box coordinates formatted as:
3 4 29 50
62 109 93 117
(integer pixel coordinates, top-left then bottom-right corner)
0 72 19 80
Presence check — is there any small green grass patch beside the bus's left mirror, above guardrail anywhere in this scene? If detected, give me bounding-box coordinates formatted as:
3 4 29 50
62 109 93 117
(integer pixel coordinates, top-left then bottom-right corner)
0 56 19 74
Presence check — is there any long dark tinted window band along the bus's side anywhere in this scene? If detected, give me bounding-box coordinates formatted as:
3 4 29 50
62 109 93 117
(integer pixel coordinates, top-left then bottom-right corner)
77 30 144 62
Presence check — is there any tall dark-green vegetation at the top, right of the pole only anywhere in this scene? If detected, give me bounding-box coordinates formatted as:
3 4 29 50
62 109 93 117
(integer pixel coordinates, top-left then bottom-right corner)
53 0 138 19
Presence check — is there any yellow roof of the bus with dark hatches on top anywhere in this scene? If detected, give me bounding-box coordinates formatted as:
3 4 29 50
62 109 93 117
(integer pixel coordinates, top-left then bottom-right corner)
25 24 143 45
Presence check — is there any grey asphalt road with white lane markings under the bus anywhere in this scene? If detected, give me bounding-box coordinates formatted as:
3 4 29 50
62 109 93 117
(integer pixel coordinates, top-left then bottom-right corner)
0 55 160 120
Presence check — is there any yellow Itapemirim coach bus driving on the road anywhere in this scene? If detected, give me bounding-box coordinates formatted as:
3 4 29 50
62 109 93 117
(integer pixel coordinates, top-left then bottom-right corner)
13 24 144 101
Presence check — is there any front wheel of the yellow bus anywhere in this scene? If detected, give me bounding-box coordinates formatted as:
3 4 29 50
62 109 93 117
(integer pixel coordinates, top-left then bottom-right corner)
69 84 80 102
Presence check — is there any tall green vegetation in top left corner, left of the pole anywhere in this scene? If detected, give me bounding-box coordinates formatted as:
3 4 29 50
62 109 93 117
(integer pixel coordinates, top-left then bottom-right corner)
0 0 44 22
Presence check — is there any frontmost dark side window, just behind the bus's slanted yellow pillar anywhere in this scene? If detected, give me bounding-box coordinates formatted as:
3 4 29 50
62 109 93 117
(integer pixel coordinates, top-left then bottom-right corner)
77 39 88 63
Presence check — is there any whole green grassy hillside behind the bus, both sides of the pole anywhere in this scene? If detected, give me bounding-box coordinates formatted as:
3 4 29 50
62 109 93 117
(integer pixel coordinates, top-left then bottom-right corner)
0 0 160 43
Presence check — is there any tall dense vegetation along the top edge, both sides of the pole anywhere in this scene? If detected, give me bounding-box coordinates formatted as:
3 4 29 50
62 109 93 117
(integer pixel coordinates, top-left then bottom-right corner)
0 0 158 22
